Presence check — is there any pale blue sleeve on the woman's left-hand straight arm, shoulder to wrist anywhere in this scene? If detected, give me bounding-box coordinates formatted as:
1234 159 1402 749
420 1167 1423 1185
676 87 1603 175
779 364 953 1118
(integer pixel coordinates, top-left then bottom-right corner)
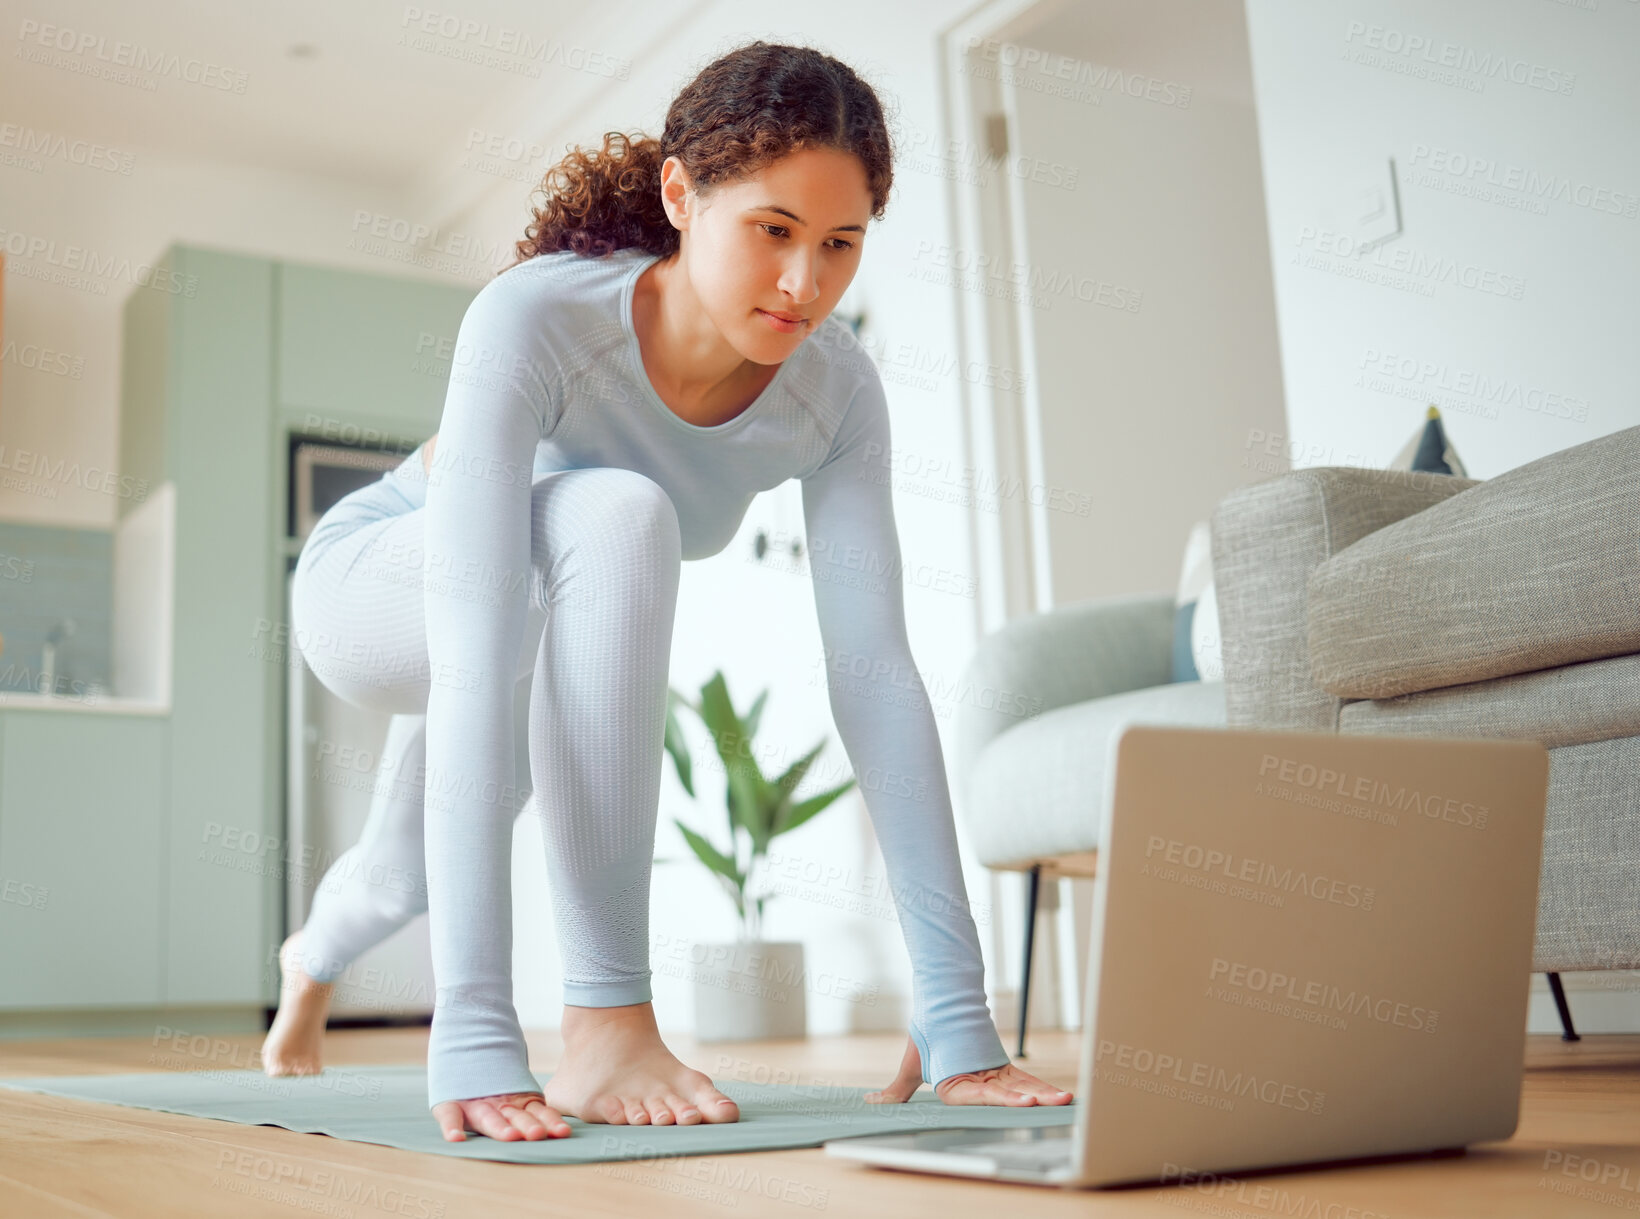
423 279 553 1107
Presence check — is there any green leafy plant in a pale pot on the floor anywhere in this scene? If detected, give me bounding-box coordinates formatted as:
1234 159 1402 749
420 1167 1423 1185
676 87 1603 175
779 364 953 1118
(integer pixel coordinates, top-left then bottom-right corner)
666 671 854 1042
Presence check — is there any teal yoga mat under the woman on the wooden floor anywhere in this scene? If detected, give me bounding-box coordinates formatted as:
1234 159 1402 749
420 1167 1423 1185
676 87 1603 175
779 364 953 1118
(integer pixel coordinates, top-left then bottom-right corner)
0 1066 1079 1163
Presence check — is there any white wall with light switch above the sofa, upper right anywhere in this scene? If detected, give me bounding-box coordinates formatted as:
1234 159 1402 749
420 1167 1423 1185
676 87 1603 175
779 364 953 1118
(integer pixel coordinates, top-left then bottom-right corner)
1248 0 1640 477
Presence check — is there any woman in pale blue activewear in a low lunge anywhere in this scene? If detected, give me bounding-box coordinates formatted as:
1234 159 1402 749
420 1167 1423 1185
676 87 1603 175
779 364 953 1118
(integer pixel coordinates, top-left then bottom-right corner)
267 43 1071 1140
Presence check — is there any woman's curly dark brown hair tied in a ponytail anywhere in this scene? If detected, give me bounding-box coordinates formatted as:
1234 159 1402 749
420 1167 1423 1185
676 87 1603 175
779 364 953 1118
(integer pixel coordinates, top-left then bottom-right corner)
508 41 894 269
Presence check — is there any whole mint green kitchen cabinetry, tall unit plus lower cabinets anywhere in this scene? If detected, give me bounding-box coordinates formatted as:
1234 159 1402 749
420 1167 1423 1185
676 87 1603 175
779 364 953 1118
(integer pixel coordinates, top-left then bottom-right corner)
0 244 477 1012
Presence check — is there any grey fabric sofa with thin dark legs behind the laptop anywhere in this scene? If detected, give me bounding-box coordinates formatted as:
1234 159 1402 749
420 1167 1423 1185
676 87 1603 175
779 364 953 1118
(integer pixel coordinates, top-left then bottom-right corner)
953 428 1640 1053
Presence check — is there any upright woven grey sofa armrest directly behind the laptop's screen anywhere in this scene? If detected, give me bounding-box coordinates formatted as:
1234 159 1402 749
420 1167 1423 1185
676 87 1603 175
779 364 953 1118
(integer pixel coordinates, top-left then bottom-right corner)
1210 466 1478 732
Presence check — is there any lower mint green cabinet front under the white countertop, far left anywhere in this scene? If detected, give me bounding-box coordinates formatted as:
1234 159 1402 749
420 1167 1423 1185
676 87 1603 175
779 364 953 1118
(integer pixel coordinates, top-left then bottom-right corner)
0 710 171 1011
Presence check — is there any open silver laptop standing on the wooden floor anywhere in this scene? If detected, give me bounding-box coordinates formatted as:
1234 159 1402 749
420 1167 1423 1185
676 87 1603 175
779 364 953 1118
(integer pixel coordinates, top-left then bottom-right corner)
825 724 1548 1188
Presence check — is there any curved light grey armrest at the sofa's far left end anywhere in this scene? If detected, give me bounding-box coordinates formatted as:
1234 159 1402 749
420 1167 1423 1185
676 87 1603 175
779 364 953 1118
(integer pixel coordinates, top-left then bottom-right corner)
953 592 1174 784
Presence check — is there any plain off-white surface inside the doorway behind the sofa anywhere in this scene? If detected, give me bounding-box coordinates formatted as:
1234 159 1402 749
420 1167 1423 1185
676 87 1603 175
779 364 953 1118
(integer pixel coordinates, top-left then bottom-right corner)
997 0 1284 604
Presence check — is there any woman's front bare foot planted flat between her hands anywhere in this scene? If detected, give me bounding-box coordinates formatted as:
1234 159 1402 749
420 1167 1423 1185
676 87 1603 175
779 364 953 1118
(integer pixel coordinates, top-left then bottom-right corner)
544 1002 740 1125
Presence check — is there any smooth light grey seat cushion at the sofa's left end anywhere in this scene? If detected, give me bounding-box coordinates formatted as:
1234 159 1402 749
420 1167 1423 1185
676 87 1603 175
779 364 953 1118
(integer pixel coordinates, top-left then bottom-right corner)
961 681 1225 868
